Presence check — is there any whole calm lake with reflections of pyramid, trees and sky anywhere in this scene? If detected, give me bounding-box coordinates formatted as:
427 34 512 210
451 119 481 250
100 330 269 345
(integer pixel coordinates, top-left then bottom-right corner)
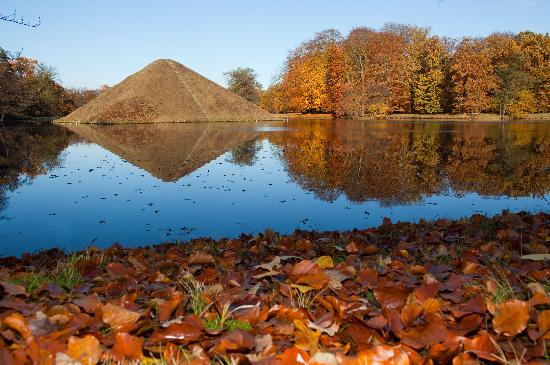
0 120 550 256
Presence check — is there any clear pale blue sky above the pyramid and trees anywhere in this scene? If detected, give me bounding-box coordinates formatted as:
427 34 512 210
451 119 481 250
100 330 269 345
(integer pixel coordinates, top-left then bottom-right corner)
0 0 550 87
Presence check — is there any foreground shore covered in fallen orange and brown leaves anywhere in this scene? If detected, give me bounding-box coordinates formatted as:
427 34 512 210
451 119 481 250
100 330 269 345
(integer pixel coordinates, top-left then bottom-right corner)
0 213 550 365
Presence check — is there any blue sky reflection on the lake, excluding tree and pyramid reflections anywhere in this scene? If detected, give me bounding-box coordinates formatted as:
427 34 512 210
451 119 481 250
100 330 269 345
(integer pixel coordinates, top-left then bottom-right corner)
0 121 550 255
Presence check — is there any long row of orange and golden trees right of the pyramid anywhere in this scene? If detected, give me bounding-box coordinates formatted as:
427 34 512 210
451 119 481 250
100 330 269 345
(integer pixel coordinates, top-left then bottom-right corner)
261 24 550 118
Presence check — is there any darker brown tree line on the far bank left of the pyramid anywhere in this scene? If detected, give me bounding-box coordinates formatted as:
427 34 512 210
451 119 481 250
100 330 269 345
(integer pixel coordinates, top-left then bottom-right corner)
0 48 106 122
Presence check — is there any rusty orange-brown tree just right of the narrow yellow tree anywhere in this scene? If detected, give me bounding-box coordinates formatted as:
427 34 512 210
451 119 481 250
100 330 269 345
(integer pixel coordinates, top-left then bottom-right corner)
450 38 497 113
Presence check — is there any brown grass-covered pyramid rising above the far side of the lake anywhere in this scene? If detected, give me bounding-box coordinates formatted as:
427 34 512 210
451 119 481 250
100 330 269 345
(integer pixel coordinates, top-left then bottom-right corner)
58 60 277 123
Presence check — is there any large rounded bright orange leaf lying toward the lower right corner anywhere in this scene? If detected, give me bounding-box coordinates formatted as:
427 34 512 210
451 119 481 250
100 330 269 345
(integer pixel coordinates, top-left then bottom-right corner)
493 299 529 336
